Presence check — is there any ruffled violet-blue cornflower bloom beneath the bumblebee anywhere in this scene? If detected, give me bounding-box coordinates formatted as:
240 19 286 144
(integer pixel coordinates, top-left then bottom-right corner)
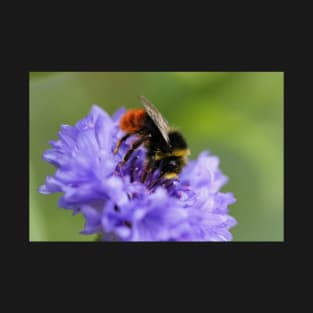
39 106 236 241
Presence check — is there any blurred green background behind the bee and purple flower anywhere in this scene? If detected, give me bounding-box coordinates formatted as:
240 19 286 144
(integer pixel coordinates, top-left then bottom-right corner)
29 72 284 241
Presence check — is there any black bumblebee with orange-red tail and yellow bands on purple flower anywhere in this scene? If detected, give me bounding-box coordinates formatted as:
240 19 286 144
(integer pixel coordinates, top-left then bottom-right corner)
114 96 190 184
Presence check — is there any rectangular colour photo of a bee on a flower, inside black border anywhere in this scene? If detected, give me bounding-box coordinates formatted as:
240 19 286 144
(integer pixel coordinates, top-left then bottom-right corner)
28 71 285 244
